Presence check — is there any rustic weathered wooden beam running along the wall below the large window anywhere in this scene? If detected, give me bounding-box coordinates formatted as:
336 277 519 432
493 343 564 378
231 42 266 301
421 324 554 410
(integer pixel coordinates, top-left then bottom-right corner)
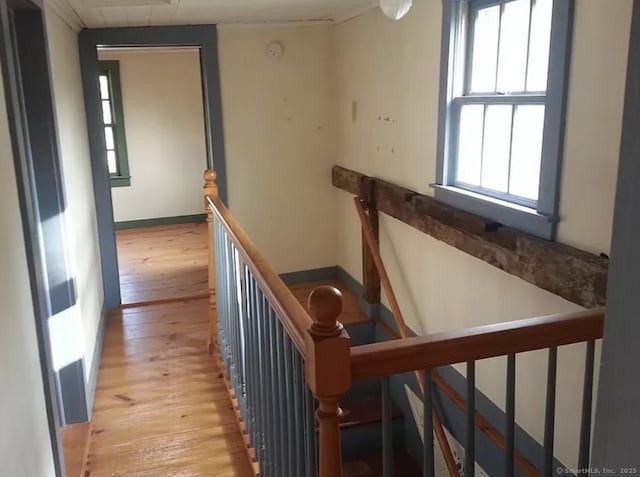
332 166 609 308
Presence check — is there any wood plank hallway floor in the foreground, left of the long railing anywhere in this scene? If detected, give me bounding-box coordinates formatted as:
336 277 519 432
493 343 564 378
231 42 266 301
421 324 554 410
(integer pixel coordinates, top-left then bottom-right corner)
85 299 253 477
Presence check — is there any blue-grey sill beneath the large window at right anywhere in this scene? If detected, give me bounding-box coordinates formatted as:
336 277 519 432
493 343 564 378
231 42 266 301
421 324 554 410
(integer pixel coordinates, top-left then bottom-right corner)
431 184 557 240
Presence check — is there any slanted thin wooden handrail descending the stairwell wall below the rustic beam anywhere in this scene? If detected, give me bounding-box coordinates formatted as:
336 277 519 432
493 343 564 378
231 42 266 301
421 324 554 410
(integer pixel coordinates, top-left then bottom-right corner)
354 197 460 477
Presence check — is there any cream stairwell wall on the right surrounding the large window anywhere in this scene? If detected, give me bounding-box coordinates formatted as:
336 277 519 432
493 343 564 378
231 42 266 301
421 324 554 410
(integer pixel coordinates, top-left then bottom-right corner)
335 0 632 466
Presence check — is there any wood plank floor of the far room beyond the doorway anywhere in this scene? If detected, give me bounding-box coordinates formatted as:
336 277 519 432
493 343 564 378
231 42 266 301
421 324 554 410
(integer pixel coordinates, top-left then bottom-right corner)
116 223 208 305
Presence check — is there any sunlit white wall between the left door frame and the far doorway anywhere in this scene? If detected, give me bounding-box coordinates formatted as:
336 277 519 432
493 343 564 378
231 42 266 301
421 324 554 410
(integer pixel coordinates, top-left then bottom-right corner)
46 9 104 402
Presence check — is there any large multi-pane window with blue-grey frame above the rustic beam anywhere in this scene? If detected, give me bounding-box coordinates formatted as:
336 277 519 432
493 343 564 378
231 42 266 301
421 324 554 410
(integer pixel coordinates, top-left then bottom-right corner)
434 0 573 239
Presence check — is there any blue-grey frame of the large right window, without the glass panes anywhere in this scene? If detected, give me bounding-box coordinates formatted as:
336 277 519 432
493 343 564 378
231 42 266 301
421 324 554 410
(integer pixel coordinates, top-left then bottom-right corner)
432 0 574 240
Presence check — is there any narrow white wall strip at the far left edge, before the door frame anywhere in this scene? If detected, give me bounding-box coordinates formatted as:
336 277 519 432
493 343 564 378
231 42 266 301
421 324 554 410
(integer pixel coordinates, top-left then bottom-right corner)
0 42 55 477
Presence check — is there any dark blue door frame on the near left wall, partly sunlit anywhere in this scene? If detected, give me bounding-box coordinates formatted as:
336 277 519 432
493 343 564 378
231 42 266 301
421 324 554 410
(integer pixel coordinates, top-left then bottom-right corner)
0 0 77 470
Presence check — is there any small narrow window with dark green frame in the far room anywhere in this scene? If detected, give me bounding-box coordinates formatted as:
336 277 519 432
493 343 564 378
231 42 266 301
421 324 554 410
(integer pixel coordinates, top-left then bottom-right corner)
98 61 131 187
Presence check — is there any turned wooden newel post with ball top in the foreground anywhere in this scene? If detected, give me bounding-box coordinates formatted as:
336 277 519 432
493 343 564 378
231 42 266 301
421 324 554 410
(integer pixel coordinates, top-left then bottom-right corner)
305 286 351 477
